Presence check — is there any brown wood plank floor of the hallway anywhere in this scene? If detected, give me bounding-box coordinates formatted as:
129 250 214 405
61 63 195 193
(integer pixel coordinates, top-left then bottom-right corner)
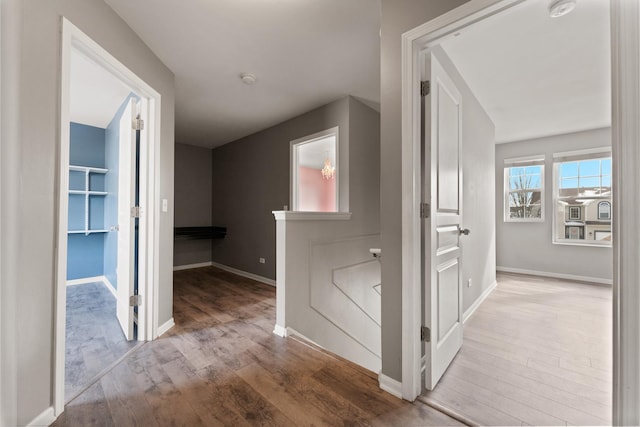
53 267 460 426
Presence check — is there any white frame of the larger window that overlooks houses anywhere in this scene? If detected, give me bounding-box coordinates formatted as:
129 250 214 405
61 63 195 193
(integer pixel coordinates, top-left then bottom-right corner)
551 147 613 248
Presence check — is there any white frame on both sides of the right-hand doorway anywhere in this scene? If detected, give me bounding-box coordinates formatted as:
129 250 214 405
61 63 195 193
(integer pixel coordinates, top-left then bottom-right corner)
403 1 638 423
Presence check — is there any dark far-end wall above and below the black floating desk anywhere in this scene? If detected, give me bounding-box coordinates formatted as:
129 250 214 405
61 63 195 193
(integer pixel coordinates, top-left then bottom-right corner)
173 144 213 266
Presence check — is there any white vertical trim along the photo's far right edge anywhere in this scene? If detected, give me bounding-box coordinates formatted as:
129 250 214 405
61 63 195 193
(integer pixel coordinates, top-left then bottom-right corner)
610 0 640 425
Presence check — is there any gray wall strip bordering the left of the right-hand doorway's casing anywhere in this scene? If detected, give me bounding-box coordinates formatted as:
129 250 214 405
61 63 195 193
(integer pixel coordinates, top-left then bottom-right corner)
380 0 466 381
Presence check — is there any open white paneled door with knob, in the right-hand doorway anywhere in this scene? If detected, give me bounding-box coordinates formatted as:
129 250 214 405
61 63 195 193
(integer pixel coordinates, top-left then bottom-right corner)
422 54 469 390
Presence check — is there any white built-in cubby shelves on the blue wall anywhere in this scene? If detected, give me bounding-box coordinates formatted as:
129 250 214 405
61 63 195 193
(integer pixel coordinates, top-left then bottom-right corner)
68 165 109 235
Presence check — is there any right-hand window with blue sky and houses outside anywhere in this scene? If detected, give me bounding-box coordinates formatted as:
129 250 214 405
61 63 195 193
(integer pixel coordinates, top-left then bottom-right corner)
553 148 611 246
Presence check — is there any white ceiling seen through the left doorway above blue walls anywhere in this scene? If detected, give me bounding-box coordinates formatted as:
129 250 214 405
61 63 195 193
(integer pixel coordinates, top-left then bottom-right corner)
69 50 130 129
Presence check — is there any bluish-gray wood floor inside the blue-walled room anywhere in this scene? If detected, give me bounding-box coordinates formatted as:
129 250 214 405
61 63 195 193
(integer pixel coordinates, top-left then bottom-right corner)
64 283 136 402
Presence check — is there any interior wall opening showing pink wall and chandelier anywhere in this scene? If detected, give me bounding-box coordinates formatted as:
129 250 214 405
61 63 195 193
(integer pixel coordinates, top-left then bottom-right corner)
291 127 340 212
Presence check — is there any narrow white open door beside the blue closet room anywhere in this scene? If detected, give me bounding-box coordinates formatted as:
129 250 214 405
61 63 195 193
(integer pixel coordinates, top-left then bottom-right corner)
116 99 136 340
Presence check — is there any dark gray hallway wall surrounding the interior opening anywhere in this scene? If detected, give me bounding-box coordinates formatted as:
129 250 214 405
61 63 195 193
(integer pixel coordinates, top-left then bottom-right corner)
212 97 380 280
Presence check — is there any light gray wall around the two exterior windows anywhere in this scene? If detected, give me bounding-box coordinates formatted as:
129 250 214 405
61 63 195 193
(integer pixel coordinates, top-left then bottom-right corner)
496 128 615 280
